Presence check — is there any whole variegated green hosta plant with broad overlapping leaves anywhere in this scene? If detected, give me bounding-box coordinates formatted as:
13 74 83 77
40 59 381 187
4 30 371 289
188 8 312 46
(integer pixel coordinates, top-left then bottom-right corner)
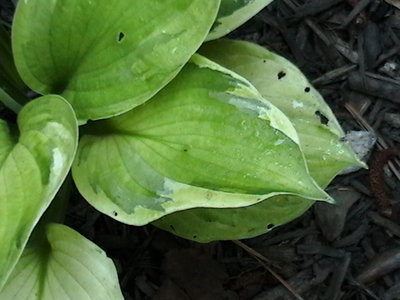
0 0 363 300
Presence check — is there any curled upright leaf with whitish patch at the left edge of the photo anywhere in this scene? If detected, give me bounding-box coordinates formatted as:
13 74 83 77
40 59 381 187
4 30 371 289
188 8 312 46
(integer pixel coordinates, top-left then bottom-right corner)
0 96 78 288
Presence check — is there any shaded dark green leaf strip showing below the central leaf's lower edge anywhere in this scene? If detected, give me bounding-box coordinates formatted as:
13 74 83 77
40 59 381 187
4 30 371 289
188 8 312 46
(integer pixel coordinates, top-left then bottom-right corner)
152 196 314 243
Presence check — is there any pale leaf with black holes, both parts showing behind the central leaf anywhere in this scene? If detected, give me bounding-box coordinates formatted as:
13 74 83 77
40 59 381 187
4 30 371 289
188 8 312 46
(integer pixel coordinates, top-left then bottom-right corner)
153 40 365 242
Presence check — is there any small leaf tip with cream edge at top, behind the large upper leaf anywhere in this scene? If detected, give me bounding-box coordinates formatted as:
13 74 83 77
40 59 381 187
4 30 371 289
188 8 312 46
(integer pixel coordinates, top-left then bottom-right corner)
207 0 273 41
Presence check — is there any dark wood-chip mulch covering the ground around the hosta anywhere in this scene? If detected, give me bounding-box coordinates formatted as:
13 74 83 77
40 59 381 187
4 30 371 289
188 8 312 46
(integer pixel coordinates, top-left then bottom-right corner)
0 0 400 300
